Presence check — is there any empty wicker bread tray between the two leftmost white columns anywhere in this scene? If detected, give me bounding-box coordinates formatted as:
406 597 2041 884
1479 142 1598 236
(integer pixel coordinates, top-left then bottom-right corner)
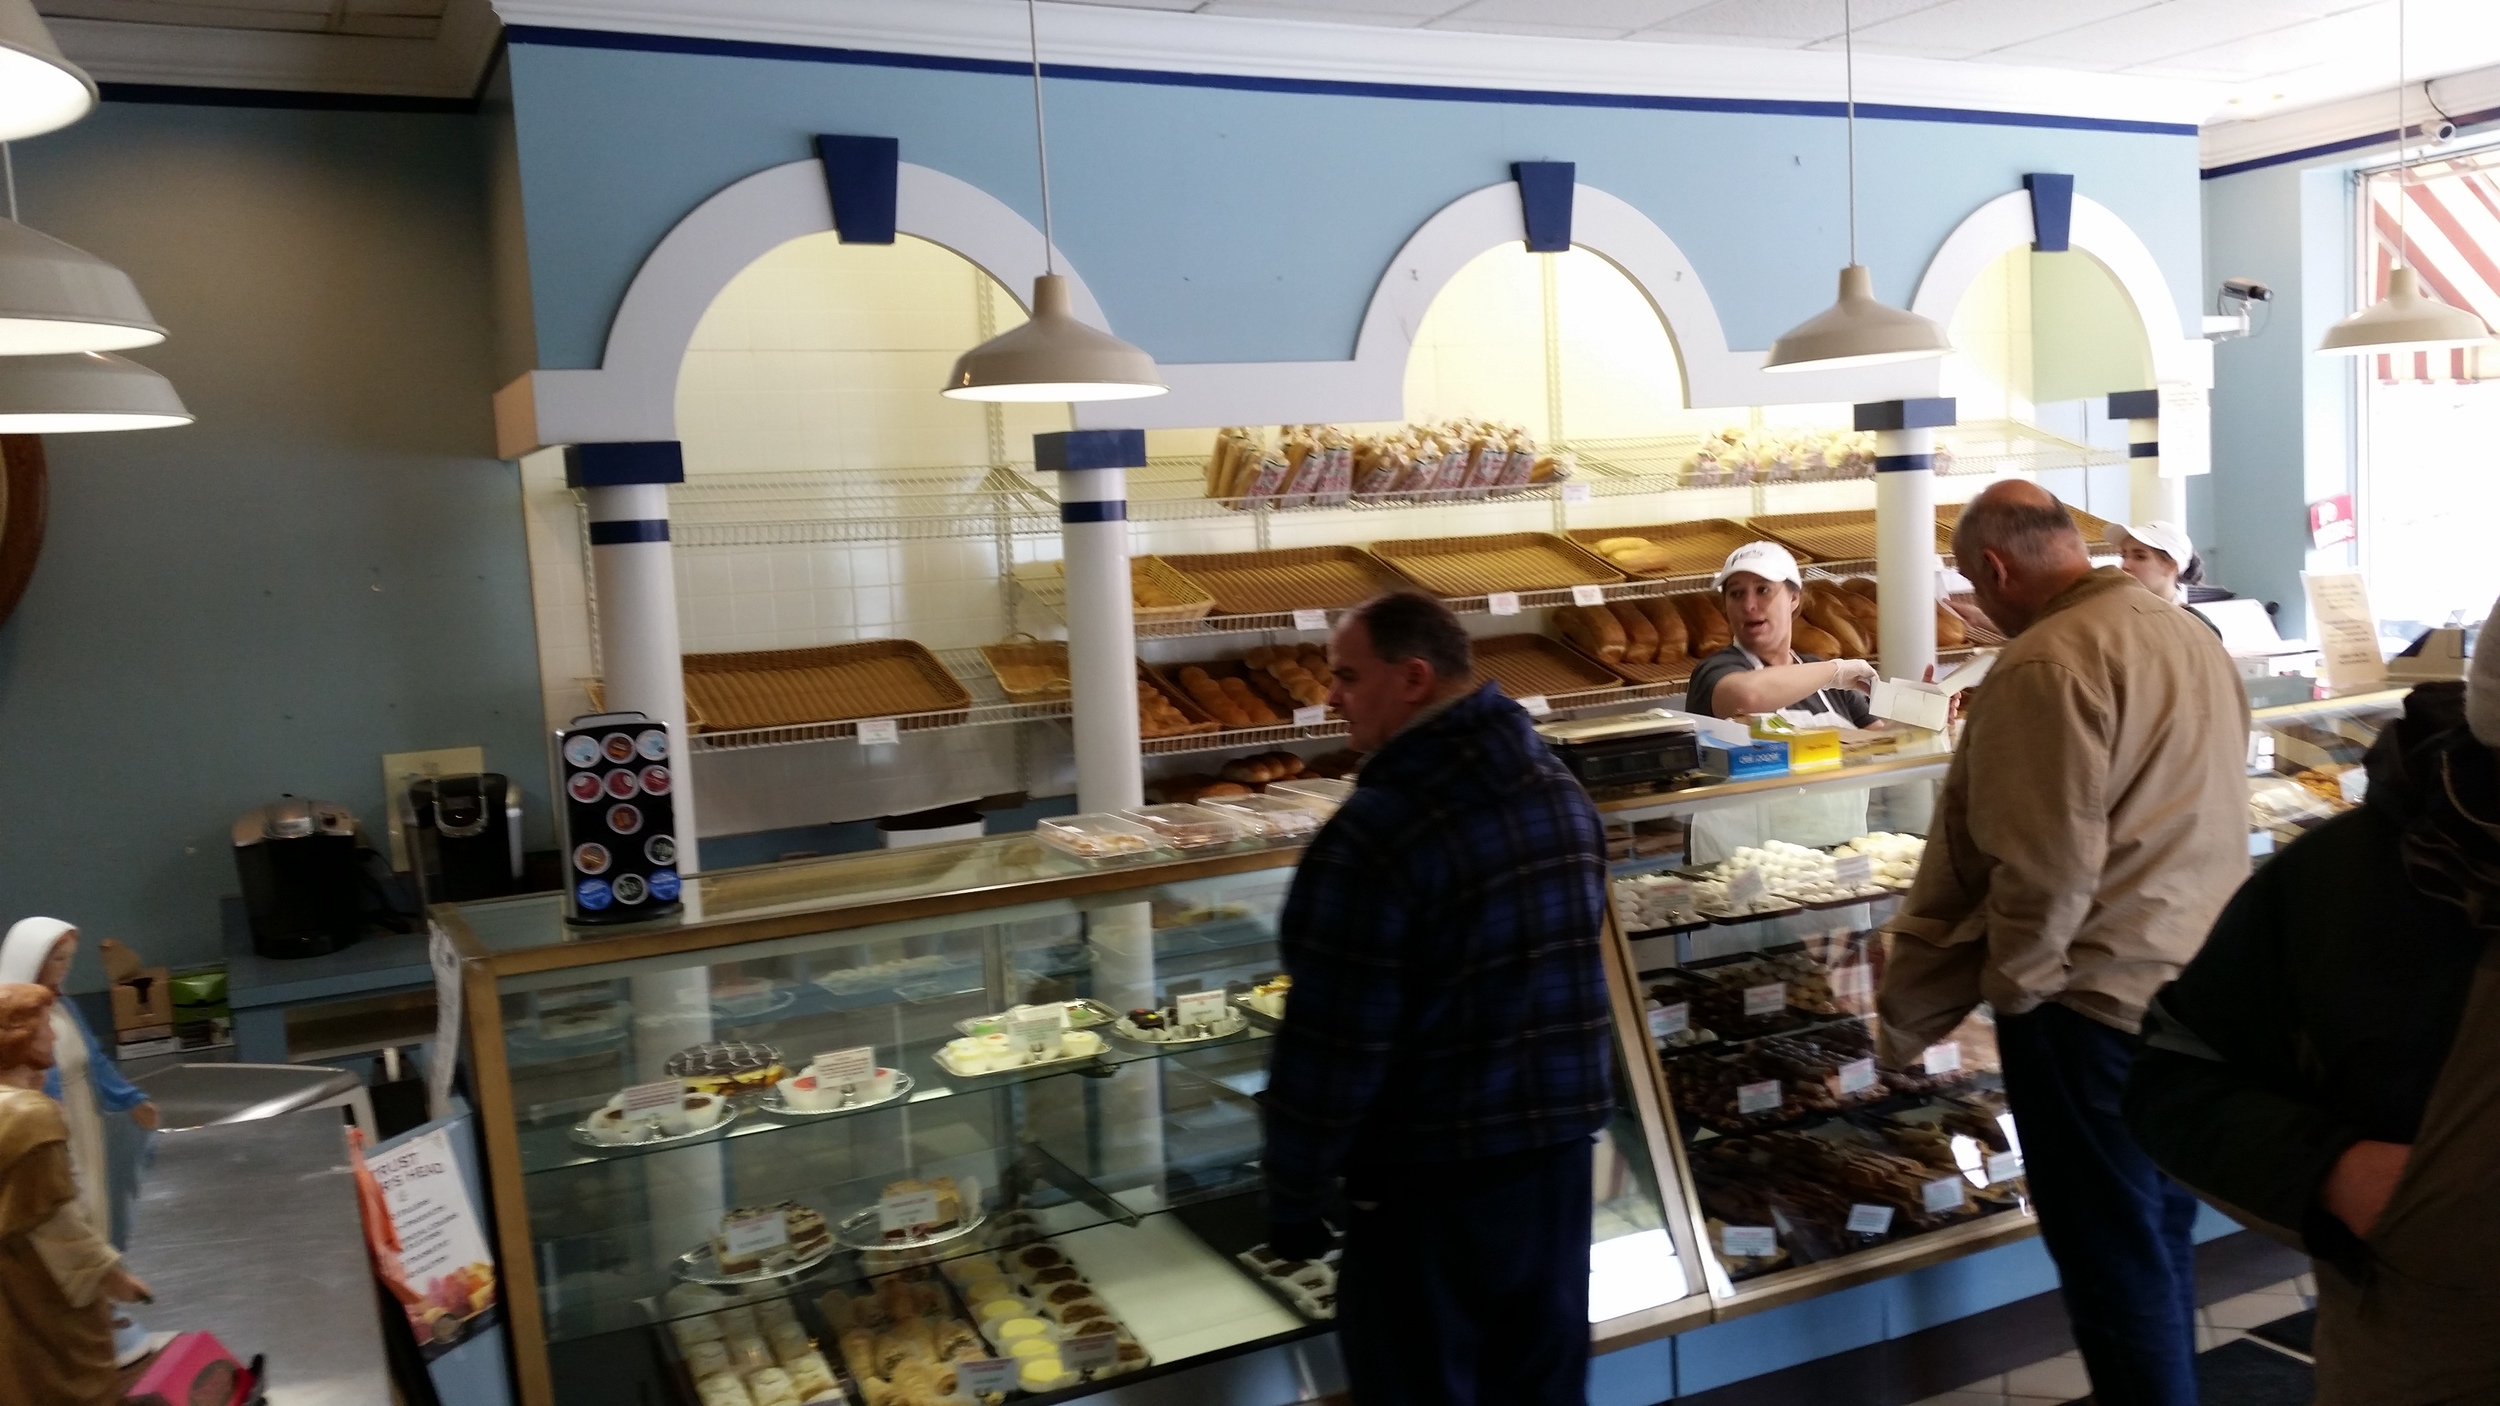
685 640 973 733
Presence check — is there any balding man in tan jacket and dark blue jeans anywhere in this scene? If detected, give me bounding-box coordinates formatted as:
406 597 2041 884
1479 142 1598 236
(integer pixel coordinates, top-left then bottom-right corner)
1880 483 2248 1406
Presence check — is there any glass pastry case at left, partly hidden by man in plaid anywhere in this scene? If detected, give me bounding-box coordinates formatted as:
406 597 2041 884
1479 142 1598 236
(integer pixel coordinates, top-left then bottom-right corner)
435 836 1710 1406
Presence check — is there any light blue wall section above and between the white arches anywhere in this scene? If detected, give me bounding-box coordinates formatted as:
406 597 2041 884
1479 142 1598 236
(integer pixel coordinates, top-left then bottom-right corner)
510 30 2203 368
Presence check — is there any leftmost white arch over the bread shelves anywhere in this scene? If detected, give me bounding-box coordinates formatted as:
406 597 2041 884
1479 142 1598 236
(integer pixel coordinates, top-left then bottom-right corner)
517 160 1110 447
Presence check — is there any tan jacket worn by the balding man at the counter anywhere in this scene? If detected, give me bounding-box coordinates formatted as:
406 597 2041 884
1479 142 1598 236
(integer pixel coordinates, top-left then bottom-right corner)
1878 568 2248 1063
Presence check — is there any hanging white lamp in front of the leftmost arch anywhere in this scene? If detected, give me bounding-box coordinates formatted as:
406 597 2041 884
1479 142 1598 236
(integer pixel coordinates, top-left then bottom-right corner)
943 0 1170 400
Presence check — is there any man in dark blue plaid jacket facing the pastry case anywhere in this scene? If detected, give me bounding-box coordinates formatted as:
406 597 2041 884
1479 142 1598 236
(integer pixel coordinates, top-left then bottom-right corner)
1263 593 1615 1406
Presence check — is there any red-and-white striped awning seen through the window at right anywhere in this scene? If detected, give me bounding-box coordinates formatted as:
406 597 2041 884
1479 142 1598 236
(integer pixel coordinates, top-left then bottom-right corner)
2365 153 2500 383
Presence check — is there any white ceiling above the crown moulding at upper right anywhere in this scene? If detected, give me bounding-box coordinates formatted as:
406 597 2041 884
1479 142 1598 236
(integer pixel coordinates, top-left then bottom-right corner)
1070 0 2500 120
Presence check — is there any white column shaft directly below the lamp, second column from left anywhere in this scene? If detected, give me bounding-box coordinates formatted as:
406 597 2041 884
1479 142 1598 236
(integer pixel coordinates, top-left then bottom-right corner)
1060 460 1145 811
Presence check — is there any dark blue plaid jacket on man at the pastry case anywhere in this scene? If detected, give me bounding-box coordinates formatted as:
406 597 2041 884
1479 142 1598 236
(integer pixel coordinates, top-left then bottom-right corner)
1260 683 1615 1221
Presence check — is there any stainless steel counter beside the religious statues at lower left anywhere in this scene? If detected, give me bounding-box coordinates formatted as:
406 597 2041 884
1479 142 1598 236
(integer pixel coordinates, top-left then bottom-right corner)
128 1108 390 1406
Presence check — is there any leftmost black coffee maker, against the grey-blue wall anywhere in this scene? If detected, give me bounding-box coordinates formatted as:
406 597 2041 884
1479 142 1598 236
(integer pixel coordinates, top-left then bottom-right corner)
235 796 368 958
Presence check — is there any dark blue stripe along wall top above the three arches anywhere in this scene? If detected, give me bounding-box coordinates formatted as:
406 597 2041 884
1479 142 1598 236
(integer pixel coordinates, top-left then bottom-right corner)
503 25 2195 138
